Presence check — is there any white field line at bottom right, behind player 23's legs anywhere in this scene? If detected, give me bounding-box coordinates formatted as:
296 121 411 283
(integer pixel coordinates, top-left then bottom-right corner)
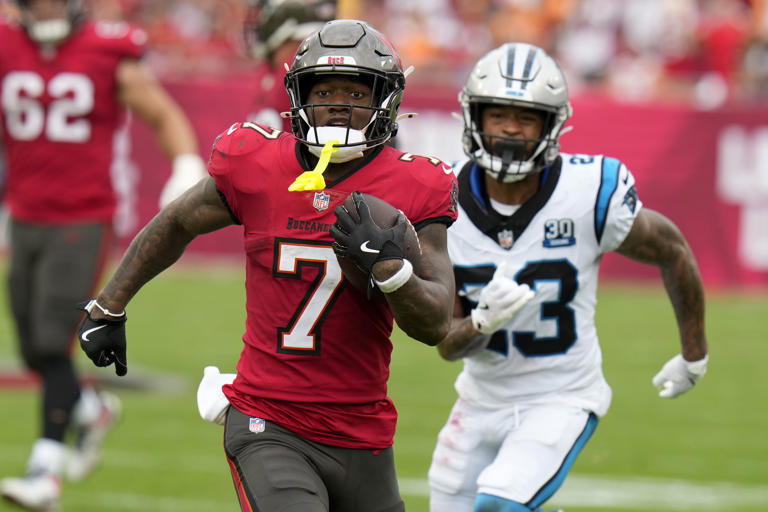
400 474 768 511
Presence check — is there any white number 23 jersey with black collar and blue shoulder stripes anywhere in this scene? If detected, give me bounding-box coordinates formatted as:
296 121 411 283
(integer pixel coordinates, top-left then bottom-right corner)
448 153 642 416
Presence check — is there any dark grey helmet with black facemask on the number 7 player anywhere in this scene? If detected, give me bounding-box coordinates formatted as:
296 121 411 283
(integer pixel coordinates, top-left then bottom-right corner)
285 19 405 154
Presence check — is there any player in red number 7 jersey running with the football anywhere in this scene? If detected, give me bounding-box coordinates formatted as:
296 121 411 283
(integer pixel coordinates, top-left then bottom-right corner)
79 20 457 512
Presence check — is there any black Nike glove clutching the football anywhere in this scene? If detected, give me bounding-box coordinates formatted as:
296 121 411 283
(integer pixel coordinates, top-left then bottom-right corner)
330 191 408 275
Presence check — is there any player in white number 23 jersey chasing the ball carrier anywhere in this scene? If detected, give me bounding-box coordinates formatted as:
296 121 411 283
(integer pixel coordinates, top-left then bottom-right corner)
429 43 707 512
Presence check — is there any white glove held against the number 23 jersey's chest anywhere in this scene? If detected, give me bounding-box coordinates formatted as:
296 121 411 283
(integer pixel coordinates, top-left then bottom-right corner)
471 261 534 334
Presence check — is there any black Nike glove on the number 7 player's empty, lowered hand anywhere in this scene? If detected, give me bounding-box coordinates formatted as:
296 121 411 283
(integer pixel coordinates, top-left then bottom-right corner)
77 300 128 377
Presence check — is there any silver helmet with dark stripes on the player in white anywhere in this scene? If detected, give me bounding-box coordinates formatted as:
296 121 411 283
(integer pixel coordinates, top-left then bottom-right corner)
459 43 573 183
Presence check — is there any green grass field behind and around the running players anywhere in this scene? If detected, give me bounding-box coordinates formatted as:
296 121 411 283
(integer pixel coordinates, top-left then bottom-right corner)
0 261 768 512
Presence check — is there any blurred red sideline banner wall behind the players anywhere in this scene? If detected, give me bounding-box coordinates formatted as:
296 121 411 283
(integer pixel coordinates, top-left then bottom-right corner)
121 78 768 287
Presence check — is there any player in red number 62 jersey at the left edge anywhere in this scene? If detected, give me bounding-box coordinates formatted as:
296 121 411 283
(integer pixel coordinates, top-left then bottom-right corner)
0 0 205 509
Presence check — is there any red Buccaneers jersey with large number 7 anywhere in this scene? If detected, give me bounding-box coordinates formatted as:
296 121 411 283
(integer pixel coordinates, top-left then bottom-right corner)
209 123 457 449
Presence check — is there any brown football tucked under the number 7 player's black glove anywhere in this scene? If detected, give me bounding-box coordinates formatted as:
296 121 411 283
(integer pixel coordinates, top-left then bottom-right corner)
336 194 421 300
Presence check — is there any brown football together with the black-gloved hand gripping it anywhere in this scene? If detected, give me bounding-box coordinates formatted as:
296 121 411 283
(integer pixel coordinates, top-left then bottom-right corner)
331 191 421 299
